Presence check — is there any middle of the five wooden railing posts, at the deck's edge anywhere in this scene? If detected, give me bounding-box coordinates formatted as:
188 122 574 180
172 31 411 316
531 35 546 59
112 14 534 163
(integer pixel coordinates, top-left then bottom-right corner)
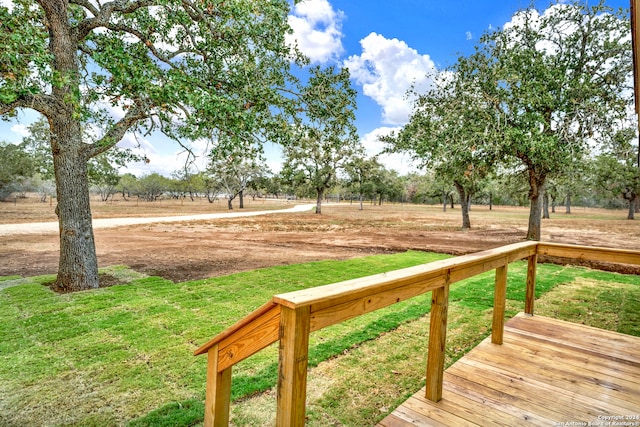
426 280 449 402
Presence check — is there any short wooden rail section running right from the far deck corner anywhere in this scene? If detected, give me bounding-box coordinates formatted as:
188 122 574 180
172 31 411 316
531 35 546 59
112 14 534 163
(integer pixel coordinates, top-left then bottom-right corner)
538 242 640 265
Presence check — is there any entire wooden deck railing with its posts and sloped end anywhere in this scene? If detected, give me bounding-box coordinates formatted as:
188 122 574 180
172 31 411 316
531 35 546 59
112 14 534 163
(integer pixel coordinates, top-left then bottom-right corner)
194 242 640 427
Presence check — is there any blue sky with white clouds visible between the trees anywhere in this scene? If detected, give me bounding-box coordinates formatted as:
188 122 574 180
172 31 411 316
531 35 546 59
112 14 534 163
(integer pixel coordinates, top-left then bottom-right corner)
0 0 629 175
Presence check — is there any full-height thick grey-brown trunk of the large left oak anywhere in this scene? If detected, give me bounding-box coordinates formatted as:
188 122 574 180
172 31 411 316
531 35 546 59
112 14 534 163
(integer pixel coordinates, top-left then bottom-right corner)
41 1 99 291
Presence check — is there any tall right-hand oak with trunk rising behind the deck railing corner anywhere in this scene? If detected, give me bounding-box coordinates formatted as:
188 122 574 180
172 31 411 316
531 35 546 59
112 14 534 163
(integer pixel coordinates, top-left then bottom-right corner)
470 1 632 240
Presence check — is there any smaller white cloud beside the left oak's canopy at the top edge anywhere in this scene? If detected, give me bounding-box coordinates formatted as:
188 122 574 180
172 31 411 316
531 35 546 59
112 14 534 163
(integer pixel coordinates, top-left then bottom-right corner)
288 0 344 63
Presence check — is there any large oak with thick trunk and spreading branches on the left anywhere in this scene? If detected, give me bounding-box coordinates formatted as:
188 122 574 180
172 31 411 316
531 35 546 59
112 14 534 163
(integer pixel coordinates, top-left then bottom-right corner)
0 0 304 290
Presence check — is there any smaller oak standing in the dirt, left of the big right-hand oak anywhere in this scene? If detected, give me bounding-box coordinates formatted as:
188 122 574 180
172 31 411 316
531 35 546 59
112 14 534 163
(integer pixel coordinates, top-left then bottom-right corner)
382 61 495 229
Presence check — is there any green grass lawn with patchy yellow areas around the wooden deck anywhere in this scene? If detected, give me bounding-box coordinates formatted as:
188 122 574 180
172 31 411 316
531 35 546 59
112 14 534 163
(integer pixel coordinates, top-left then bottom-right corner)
0 252 640 427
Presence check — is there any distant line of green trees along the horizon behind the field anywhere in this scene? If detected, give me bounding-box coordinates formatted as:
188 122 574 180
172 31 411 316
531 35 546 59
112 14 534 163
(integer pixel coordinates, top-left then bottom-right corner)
0 121 635 214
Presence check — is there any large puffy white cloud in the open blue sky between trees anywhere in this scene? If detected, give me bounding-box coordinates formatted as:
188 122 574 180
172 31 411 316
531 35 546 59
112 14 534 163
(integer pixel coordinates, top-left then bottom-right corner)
344 33 437 125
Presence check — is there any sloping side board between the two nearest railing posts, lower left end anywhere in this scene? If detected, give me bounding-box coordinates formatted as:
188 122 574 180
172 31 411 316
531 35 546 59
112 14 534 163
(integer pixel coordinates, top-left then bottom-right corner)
218 305 281 371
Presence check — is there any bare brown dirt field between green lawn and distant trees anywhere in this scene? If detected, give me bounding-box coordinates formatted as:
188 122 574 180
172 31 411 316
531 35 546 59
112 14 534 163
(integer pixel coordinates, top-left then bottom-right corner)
0 197 640 282
